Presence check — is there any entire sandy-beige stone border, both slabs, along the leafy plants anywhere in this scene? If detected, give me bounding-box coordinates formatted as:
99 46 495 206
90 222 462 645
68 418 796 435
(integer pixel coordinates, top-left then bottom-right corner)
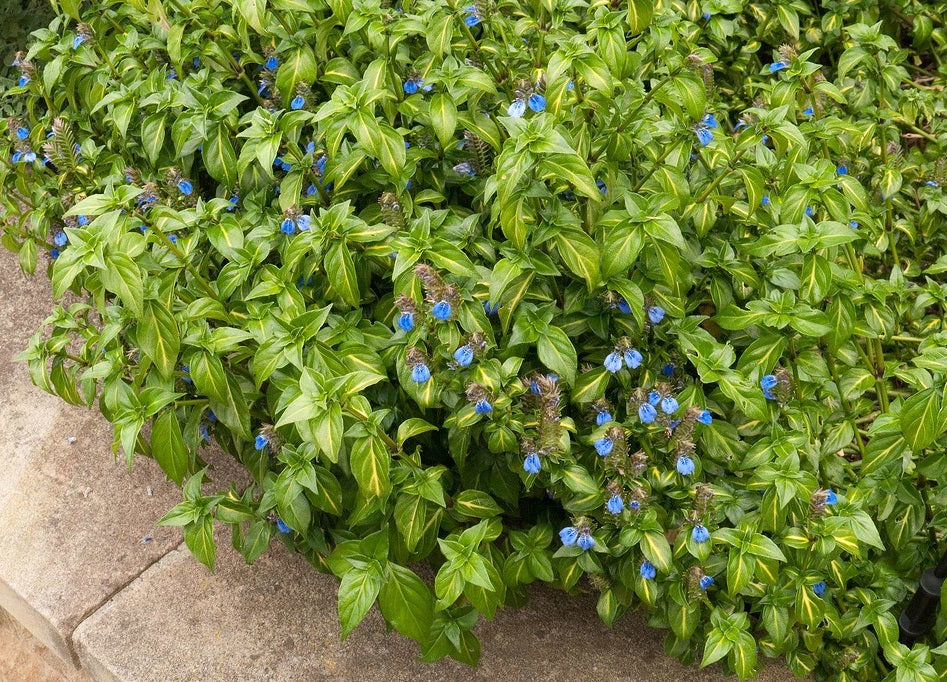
0 249 795 682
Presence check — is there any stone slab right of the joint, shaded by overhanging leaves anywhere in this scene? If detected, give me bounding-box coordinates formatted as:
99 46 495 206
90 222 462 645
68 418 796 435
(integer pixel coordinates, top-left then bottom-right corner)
75 537 795 682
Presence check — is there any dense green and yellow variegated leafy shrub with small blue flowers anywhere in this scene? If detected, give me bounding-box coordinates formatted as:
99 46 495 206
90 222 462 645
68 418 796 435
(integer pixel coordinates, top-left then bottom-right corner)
3 0 947 680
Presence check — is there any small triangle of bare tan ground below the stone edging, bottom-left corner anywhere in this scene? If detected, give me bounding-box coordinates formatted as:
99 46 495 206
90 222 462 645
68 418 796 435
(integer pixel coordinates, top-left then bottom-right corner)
0 609 90 682
